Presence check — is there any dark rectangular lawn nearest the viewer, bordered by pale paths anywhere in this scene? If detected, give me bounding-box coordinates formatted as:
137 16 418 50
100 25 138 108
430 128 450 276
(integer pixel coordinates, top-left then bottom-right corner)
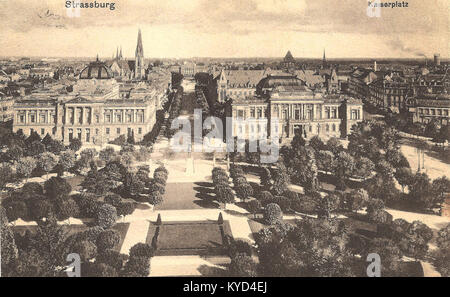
151 221 231 255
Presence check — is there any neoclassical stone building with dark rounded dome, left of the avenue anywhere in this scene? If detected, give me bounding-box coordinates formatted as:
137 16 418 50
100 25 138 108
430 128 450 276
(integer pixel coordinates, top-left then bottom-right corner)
13 59 158 145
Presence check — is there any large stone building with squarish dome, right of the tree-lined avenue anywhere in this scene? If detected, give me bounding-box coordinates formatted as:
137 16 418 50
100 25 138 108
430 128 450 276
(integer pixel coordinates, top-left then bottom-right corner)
227 74 363 142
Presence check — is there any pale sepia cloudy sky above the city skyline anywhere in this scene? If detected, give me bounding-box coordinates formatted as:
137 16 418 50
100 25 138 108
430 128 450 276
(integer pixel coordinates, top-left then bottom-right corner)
0 0 450 58
